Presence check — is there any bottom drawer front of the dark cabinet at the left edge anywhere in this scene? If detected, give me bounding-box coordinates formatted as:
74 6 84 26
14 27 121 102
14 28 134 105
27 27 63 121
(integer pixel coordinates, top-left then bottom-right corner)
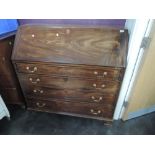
0 88 23 104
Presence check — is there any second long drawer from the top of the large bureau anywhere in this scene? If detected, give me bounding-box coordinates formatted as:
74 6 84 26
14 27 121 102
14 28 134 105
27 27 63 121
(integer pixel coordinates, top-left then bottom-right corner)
19 74 120 93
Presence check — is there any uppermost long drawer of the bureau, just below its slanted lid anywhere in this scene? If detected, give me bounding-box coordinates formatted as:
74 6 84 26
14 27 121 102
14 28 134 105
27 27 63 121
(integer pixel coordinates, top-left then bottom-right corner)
15 63 123 80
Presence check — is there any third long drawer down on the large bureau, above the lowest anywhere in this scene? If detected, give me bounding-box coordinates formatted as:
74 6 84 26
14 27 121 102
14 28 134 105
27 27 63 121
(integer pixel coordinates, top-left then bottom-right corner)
23 86 116 104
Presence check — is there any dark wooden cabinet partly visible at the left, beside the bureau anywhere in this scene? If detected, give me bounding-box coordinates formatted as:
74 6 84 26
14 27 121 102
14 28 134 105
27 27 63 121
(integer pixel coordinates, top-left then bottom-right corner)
0 35 24 105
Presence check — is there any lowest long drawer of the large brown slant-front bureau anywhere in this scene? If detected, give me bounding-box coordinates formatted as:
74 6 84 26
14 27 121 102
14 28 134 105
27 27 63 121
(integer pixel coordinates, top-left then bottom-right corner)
27 98 114 119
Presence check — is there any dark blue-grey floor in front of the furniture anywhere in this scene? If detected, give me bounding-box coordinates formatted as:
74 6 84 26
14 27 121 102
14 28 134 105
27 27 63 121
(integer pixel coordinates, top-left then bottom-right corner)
0 107 155 135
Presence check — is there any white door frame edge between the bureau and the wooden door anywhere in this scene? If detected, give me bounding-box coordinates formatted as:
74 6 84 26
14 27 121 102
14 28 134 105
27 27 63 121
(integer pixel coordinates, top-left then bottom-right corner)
113 19 150 120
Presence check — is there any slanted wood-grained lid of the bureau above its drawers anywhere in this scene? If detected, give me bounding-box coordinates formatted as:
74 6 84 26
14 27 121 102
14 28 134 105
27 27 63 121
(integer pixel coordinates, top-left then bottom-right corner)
12 25 128 67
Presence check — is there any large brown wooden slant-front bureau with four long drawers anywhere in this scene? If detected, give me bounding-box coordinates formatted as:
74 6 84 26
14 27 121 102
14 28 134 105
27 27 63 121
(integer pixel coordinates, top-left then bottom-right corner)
12 25 128 121
